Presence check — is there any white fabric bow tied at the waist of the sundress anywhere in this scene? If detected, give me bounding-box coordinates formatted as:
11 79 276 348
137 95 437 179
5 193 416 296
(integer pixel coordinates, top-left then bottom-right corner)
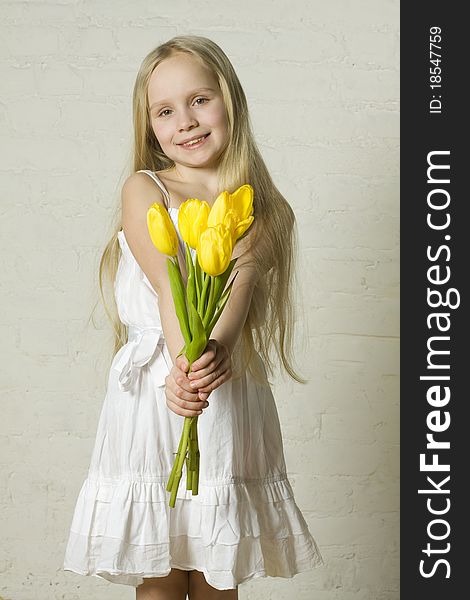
114 326 167 392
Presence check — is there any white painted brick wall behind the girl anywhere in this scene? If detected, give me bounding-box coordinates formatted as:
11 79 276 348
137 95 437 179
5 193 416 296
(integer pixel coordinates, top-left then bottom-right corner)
0 0 399 600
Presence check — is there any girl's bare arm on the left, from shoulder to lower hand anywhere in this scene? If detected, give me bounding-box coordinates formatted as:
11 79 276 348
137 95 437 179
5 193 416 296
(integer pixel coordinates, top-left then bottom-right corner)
121 173 205 417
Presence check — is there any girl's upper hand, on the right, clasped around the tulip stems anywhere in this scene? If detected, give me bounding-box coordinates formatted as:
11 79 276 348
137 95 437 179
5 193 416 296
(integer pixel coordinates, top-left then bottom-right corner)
179 339 232 400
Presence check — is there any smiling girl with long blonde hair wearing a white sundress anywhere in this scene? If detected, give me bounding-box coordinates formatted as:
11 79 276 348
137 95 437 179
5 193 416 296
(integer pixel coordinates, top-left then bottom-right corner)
64 36 322 600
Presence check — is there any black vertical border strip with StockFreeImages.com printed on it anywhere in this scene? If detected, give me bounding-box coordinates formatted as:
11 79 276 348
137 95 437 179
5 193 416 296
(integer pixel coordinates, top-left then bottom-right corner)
400 1 470 600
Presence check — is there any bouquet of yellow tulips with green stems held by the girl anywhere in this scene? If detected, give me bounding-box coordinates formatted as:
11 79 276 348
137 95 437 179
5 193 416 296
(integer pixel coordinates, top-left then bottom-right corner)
147 184 254 508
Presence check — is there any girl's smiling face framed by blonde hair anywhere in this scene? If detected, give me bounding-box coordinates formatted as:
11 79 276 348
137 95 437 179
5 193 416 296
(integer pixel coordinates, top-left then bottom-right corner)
148 53 229 167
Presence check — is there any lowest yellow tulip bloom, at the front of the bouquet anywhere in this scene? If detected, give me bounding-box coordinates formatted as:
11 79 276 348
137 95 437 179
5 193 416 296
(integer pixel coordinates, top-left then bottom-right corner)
197 223 233 277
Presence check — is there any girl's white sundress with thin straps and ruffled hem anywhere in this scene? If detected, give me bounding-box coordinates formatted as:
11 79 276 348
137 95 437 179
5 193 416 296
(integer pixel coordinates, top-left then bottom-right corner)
63 171 323 590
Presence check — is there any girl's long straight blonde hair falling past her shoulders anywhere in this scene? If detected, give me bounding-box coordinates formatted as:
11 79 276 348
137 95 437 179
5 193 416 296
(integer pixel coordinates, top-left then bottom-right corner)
99 35 306 384
